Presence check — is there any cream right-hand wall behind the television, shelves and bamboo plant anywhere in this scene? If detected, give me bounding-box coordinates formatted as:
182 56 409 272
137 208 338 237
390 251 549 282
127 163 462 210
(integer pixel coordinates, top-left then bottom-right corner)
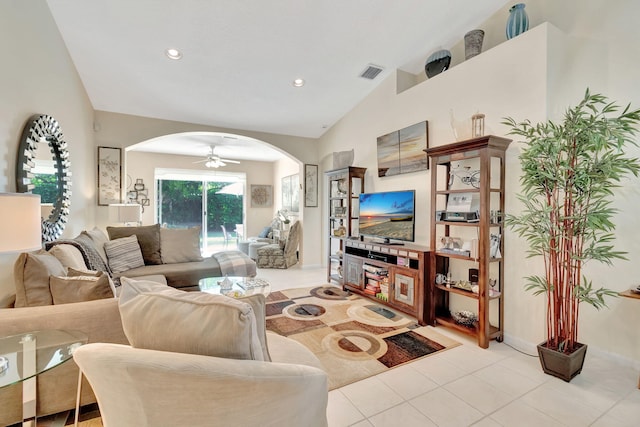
318 0 640 363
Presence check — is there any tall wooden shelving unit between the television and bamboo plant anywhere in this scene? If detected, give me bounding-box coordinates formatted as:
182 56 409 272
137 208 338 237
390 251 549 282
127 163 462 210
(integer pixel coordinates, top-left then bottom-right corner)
426 135 511 348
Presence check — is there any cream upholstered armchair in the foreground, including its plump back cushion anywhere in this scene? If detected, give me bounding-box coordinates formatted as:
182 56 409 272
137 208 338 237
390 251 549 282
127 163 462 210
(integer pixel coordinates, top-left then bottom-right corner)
73 278 328 427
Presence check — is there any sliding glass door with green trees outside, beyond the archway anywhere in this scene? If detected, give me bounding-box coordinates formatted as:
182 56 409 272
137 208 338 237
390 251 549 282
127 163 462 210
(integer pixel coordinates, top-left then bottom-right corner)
156 170 245 256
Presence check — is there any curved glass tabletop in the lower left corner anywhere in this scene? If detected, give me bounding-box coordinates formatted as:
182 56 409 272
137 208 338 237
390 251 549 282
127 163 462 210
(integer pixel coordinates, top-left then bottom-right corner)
0 329 88 388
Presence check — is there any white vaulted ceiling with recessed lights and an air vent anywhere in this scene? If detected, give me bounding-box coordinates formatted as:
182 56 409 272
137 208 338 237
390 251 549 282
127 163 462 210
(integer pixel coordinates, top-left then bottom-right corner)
47 0 507 160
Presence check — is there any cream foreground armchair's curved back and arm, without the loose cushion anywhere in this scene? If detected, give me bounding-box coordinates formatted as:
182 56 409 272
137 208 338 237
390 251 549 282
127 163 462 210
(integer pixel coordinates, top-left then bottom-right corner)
73 333 328 427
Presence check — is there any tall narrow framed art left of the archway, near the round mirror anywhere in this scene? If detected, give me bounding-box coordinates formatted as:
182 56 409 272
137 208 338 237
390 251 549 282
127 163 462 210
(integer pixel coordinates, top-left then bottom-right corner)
98 147 122 206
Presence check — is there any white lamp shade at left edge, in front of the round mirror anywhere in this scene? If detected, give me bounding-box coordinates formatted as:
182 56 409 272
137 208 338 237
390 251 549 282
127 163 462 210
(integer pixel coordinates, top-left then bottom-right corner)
0 193 42 253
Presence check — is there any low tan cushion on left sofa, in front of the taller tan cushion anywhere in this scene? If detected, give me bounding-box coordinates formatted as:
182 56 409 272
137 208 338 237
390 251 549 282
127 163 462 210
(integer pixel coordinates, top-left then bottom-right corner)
49 272 115 304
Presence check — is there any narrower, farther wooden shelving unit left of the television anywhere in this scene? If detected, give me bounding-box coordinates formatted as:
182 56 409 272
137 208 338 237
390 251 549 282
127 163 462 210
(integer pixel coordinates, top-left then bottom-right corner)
324 166 367 285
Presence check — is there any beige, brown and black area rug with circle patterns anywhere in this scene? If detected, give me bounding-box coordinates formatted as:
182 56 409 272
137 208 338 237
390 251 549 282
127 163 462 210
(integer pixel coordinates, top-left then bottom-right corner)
266 285 460 390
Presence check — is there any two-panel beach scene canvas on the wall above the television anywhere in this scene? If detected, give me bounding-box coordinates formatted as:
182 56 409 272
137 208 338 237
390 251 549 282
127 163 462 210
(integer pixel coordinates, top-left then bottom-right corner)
377 121 429 176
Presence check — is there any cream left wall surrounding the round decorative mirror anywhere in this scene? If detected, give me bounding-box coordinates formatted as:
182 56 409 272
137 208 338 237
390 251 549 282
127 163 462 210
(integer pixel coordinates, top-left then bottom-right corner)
0 0 96 299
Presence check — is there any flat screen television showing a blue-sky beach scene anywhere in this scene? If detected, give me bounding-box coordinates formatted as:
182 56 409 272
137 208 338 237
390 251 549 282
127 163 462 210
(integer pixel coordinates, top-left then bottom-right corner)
359 190 416 244
